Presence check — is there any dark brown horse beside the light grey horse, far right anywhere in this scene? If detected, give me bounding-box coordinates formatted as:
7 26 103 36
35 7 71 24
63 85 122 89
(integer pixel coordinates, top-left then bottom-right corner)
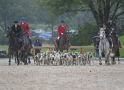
110 26 120 64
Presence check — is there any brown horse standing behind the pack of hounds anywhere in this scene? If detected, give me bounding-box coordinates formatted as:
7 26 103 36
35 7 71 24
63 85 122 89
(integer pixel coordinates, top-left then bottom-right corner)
54 29 69 52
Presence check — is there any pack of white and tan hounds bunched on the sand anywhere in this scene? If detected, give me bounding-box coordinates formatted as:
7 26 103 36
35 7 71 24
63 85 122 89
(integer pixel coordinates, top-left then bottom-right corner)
33 51 94 66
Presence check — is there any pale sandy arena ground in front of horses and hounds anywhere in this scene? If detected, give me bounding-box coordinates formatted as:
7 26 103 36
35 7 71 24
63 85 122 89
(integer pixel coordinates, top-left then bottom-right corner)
0 58 124 90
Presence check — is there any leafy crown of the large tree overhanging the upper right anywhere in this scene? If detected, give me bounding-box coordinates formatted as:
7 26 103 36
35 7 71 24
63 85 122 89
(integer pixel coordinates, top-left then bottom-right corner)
35 0 124 26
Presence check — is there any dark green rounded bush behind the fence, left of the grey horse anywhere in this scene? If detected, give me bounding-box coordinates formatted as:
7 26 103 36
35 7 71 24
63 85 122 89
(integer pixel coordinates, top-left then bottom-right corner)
70 23 99 46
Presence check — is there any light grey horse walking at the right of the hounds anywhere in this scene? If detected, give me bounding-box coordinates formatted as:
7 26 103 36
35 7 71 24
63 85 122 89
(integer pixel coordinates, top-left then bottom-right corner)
99 28 110 65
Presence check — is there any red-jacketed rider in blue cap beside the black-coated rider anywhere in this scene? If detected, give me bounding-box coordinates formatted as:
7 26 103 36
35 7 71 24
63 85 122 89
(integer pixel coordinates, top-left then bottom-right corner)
19 17 32 47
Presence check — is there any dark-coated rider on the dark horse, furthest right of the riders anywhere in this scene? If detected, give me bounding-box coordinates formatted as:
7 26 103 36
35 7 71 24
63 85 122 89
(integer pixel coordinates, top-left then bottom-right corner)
107 17 122 48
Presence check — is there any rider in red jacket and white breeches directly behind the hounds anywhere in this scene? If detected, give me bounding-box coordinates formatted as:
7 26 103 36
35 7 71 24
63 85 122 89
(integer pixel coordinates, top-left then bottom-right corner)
57 20 66 48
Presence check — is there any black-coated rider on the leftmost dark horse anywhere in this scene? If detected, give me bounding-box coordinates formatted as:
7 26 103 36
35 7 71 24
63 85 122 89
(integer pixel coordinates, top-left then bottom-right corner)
11 21 24 50
